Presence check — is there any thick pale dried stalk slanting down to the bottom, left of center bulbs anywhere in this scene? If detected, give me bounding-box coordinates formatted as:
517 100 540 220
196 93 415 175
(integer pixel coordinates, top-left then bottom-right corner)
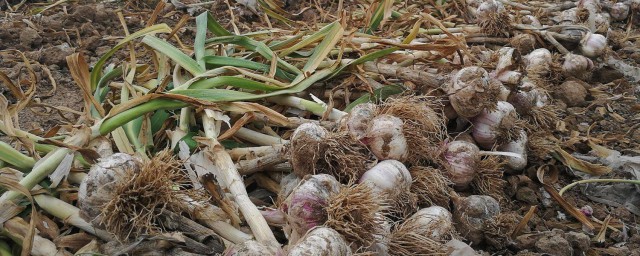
202 115 280 248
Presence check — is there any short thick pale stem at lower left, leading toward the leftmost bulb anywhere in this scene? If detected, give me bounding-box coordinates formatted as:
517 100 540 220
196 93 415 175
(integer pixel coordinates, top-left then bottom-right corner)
33 194 114 241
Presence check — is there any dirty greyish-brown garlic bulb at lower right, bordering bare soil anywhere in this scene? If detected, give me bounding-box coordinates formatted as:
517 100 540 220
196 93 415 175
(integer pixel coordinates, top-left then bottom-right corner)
451 195 500 245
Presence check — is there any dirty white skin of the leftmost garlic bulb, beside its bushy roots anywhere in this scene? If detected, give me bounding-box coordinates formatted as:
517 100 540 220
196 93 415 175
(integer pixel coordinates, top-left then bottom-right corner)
78 153 142 226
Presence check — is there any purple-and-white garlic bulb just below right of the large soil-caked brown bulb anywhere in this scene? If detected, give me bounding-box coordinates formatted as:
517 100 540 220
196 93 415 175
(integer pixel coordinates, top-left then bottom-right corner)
471 101 518 149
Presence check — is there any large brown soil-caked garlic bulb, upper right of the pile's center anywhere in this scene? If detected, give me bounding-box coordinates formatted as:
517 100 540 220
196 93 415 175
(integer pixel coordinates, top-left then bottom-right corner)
447 66 501 118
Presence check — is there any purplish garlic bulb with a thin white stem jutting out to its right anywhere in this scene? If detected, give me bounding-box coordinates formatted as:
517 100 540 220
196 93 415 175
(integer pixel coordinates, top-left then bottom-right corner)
444 141 480 190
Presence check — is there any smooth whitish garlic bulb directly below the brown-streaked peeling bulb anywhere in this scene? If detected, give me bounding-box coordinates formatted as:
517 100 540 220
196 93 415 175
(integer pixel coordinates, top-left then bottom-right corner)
358 160 412 197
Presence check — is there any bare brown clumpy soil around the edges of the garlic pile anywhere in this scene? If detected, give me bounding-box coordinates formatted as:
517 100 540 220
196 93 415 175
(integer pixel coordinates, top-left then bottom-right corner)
0 0 640 256
